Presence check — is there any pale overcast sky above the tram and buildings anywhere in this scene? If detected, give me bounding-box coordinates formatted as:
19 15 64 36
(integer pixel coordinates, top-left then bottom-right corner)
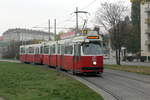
0 0 130 35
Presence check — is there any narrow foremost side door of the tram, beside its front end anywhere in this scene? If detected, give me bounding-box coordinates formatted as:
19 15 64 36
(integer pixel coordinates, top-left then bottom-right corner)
73 44 81 70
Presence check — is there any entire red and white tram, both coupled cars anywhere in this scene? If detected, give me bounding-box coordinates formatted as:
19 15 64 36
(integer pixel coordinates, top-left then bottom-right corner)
20 33 103 74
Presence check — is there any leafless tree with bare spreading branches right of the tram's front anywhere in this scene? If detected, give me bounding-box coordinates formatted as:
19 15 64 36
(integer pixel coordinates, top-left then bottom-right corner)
96 1 127 65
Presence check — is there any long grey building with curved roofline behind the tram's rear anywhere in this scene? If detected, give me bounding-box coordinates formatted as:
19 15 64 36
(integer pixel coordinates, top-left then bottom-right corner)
3 28 54 41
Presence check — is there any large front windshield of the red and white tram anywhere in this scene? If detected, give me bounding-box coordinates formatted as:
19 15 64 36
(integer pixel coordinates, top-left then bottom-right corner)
82 42 103 55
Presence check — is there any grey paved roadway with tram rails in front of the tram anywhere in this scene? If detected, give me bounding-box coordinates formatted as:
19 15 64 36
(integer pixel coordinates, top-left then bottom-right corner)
82 69 150 100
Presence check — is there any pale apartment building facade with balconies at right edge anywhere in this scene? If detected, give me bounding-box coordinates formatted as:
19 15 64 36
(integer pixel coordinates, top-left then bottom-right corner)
141 2 150 56
